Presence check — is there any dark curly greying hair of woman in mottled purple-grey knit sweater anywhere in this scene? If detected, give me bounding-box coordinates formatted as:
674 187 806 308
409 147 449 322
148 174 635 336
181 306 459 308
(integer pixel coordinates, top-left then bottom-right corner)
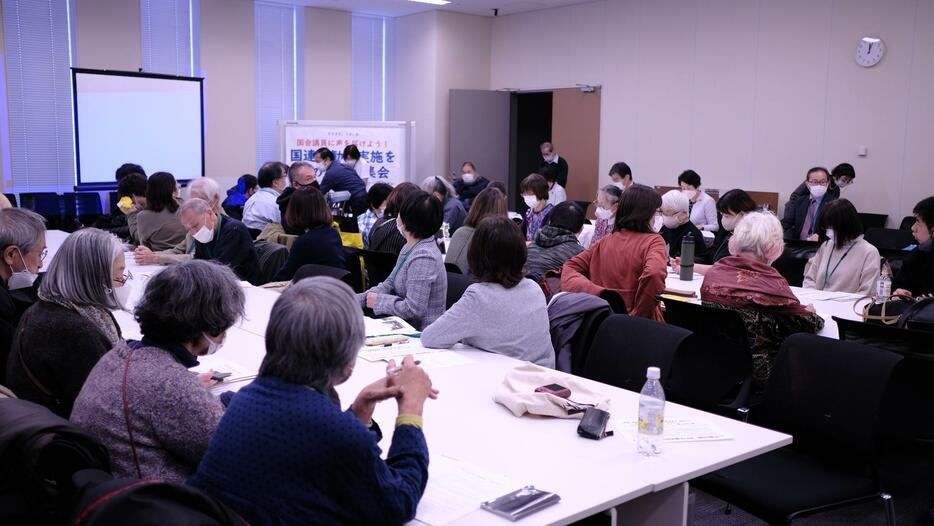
135 260 244 344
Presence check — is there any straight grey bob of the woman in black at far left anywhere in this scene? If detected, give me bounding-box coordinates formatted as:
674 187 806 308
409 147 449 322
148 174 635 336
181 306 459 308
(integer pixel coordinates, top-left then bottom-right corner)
39 228 123 309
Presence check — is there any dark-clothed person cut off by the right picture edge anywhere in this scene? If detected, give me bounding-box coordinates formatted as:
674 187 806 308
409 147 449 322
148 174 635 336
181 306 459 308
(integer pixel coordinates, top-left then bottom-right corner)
892 197 934 296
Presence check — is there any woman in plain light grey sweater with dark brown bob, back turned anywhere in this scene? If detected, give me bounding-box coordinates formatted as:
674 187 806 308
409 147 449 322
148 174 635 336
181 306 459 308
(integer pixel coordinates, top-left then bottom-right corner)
422 218 556 368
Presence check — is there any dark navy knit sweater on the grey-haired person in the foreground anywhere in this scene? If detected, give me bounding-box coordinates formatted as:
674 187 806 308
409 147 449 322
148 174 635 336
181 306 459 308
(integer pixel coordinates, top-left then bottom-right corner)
188 376 428 526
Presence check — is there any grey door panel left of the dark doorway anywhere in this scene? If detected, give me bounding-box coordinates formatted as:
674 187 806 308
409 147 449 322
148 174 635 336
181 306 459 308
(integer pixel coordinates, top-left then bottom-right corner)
448 89 510 190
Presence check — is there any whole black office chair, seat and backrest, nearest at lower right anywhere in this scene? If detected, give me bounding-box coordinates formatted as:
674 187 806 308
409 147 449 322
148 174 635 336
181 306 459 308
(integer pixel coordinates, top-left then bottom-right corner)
691 334 902 525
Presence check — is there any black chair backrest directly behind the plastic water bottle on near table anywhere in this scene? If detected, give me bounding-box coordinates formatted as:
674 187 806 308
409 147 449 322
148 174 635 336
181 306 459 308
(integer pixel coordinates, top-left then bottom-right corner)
582 314 691 393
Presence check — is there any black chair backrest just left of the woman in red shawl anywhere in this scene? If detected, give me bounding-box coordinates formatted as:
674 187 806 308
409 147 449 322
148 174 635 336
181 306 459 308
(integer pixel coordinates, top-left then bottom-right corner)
664 300 752 416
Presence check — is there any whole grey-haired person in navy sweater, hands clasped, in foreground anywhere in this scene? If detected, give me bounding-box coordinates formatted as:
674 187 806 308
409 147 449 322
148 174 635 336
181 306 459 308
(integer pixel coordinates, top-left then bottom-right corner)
189 277 437 525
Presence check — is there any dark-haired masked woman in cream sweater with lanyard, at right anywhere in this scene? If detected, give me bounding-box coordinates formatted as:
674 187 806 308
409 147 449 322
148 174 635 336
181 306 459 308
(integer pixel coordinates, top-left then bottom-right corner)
802 199 881 296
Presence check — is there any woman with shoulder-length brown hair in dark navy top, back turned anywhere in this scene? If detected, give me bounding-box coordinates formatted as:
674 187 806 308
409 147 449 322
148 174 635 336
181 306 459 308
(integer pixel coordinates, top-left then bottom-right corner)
273 188 344 281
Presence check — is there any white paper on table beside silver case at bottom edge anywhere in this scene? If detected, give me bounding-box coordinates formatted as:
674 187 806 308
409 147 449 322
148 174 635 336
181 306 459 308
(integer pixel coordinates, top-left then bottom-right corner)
415 455 525 526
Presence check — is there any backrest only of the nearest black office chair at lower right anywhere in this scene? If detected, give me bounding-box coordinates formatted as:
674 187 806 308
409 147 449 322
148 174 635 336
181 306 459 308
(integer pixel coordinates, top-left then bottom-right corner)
754 333 902 470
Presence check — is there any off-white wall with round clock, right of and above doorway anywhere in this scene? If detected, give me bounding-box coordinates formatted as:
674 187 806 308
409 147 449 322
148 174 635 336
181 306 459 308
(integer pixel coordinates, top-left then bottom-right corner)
490 0 934 224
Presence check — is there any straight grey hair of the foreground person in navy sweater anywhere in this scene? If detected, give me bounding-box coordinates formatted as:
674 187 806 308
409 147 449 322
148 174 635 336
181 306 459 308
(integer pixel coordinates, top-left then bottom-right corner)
259 276 366 394
